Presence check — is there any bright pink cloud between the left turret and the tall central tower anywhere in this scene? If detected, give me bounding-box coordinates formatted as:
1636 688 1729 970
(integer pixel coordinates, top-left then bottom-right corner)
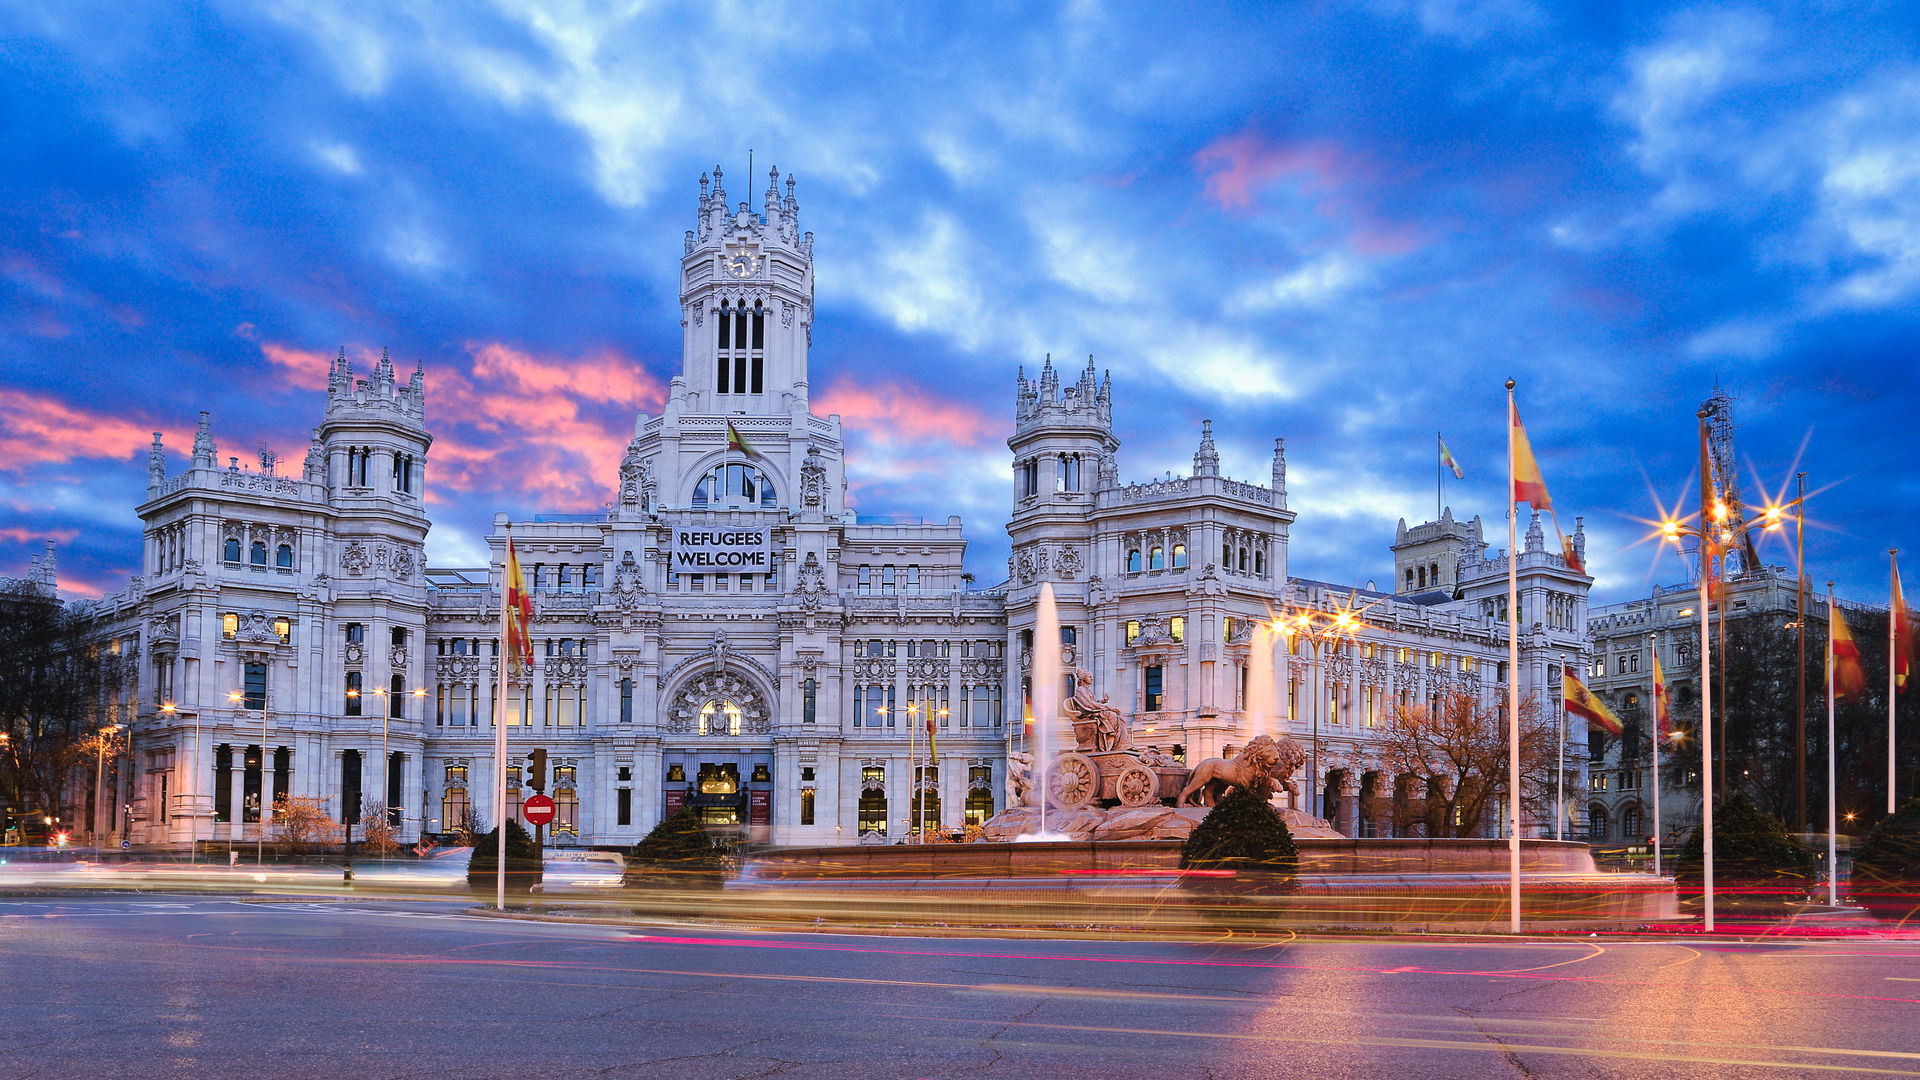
426 342 666 509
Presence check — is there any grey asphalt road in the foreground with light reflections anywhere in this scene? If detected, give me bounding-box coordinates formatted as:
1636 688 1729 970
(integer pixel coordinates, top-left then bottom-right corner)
0 897 1920 1080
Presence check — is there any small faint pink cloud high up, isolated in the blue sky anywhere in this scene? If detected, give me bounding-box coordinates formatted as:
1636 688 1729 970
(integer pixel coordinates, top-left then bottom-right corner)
1194 131 1425 256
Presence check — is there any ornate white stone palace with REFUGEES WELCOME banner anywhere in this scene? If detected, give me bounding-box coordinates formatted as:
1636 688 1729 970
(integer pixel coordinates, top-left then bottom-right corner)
86 169 1590 846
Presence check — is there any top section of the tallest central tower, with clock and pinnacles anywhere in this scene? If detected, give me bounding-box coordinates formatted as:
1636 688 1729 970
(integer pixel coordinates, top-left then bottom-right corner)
680 165 814 415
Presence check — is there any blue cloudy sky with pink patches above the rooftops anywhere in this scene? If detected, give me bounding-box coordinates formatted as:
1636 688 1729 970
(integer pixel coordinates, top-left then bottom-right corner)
0 0 1920 601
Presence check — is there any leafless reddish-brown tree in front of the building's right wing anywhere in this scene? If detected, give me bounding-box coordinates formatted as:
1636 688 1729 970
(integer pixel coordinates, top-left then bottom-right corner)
1379 692 1553 836
